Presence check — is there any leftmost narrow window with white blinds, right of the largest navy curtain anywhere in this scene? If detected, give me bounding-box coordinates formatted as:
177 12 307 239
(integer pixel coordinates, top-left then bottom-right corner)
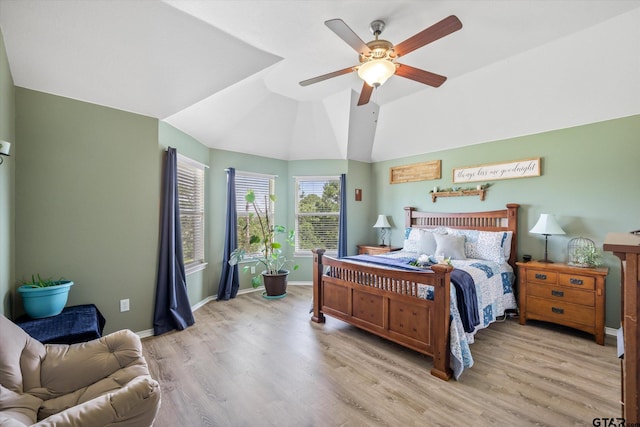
178 155 206 273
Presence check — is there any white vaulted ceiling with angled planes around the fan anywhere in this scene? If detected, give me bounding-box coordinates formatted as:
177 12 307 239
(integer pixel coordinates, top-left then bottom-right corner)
0 0 640 162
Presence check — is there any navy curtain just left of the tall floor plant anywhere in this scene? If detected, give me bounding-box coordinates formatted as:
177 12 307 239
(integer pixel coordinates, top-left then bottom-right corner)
218 168 240 300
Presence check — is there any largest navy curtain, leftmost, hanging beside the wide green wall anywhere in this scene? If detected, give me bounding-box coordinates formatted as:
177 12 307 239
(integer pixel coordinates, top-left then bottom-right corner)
153 147 195 335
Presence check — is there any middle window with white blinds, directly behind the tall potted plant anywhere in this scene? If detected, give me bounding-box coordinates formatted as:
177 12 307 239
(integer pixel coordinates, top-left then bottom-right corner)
236 172 275 256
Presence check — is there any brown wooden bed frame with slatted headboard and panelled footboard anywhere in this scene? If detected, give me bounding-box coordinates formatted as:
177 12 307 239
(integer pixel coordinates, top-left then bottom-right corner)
311 204 520 380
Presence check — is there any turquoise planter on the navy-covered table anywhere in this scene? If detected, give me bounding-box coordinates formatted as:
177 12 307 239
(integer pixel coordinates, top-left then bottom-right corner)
18 280 73 319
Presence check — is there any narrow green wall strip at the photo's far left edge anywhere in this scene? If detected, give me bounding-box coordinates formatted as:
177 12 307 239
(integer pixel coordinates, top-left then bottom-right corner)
0 31 16 317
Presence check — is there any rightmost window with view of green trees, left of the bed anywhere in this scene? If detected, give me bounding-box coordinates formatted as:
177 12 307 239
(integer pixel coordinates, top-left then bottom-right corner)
296 177 340 254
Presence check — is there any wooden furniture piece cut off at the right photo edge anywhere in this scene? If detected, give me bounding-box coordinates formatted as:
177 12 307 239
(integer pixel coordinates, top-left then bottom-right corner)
603 233 640 425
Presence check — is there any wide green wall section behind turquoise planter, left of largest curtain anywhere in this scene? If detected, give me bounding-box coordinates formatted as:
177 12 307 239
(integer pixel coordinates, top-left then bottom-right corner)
15 88 161 332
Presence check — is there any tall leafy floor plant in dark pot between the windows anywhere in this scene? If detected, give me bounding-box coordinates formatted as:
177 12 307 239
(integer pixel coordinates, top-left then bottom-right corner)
229 190 298 298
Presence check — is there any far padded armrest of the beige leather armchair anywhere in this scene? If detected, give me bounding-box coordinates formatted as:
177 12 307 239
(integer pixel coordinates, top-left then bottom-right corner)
37 330 148 398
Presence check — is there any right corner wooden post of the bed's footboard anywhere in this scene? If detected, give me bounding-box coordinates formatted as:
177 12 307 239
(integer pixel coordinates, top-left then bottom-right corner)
431 264 453 381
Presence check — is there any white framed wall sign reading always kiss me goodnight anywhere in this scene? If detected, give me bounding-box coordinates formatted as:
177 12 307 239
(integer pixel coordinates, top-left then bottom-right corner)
453 157 540 184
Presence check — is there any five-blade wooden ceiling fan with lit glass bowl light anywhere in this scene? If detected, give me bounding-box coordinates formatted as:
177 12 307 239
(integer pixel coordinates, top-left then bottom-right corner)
300 15 462 105
